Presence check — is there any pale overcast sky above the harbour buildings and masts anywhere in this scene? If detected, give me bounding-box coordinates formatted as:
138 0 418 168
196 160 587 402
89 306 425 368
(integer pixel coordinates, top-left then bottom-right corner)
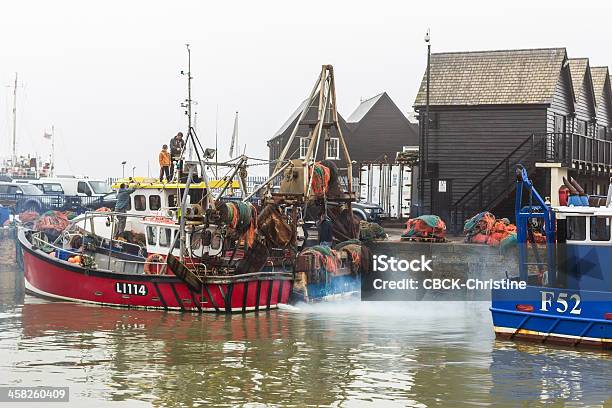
0 0 612 177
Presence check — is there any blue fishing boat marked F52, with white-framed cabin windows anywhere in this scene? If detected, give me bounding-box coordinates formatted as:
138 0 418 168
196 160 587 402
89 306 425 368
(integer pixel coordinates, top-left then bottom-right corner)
491 168 612 350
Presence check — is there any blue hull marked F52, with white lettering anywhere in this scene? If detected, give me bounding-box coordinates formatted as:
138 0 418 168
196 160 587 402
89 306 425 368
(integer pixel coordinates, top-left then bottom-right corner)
491 286 612 349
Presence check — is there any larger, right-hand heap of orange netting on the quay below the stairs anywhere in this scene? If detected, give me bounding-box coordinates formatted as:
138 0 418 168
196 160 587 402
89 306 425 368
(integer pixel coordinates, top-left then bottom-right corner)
463 211 516 247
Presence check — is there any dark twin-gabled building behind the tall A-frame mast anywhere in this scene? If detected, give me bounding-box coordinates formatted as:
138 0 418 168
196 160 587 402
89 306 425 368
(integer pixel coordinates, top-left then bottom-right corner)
267 92 418 172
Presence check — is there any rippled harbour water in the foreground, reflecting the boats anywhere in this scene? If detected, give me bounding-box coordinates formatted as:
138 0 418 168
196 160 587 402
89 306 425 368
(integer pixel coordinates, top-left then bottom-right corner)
0 247 612 407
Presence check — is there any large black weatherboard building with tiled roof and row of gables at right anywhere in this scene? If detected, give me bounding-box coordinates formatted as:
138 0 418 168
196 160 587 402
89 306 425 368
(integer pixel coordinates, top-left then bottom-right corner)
414 48 612 230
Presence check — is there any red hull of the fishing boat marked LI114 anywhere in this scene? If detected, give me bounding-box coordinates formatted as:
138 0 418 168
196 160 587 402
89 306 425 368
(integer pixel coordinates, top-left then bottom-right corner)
19 232 293 313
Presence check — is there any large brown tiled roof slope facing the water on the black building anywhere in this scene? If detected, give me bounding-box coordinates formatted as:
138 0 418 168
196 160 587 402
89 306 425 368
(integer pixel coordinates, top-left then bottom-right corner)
414 48 566 106
